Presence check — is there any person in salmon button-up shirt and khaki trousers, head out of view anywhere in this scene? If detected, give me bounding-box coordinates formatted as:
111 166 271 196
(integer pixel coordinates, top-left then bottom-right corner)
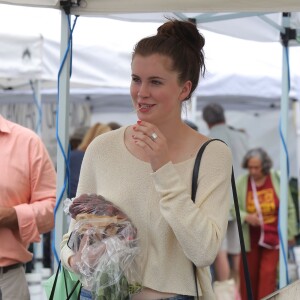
0 115 56 300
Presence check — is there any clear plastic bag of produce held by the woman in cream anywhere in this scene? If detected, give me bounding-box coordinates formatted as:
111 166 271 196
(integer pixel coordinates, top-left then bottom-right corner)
64 194 141 300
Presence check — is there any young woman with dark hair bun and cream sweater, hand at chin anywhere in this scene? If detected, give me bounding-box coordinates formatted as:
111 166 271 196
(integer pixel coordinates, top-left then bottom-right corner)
61 20 232 300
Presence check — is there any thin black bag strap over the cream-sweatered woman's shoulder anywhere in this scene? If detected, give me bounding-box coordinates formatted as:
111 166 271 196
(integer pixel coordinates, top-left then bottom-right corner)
192 139 253 300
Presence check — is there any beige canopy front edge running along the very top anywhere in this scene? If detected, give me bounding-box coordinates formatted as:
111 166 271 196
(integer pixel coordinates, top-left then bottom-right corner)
0 0 300 14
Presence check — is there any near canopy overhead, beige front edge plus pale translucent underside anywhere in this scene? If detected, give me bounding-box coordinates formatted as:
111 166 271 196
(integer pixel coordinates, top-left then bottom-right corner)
0 0 300 41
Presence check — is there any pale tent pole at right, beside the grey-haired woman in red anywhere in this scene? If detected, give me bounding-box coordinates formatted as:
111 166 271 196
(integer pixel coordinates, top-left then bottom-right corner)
279 45 289 288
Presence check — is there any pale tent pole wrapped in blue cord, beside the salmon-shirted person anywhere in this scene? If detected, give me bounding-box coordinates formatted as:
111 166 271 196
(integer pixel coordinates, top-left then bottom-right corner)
54 10 70 269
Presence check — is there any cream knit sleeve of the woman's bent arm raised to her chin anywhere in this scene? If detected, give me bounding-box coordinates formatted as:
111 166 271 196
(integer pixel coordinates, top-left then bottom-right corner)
152 141 232 267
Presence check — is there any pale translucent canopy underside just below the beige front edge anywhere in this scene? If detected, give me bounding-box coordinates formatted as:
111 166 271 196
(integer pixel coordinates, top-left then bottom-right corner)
72 12 300 42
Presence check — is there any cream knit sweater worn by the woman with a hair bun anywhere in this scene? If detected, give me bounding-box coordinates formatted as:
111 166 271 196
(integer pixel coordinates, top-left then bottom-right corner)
61 127 232 300
